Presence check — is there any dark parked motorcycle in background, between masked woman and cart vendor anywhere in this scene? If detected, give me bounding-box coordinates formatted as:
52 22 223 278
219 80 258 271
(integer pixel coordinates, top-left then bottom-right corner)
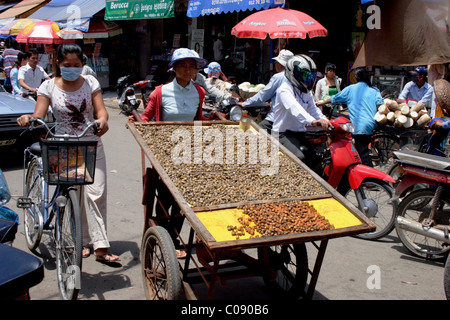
116 75 153 116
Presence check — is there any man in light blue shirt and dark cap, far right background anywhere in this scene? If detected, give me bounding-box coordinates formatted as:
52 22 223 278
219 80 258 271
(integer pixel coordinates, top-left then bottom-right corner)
398 67 433 104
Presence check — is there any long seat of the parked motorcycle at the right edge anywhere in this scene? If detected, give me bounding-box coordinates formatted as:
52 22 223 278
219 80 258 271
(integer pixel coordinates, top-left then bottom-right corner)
394 149 450 172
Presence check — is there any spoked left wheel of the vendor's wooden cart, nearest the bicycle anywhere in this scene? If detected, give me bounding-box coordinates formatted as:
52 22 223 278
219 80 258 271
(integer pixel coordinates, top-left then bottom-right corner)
141 226 182 300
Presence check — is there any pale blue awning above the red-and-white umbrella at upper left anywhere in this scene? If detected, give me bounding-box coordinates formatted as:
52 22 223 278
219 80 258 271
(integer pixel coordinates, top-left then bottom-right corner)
30 0 105 32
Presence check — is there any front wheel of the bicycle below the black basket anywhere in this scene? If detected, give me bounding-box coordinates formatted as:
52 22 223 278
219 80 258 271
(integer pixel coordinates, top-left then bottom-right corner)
55 189 82 300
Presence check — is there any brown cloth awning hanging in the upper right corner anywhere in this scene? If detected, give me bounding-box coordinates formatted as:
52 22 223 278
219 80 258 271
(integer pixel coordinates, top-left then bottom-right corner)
353 0 450 68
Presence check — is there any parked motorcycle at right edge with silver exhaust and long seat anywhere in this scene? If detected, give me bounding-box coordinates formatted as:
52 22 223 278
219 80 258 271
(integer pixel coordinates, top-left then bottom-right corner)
394 120 450 259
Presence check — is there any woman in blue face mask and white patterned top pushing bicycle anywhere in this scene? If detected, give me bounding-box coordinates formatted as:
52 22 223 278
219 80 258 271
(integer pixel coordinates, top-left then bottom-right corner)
17 44 119 263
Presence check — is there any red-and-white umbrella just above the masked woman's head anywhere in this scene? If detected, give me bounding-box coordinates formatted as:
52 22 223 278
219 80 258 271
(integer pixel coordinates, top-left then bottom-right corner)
16 20 74 44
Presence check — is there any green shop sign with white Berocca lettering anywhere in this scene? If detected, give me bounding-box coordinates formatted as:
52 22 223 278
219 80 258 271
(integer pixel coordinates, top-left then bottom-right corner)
105 0 175 20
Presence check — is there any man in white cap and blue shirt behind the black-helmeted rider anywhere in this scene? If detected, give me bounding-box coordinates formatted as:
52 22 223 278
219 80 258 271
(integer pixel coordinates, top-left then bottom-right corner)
242 49 294 133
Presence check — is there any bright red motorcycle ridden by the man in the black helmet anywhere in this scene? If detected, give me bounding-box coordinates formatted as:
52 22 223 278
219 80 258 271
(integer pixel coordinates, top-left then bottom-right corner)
302 116 395 240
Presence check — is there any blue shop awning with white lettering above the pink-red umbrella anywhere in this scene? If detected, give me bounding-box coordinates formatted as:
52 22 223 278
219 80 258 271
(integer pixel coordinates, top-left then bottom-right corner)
187 0 284 18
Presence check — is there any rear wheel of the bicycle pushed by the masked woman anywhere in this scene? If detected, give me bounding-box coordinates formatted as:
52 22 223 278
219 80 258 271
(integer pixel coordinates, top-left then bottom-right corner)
24 158 45 252
